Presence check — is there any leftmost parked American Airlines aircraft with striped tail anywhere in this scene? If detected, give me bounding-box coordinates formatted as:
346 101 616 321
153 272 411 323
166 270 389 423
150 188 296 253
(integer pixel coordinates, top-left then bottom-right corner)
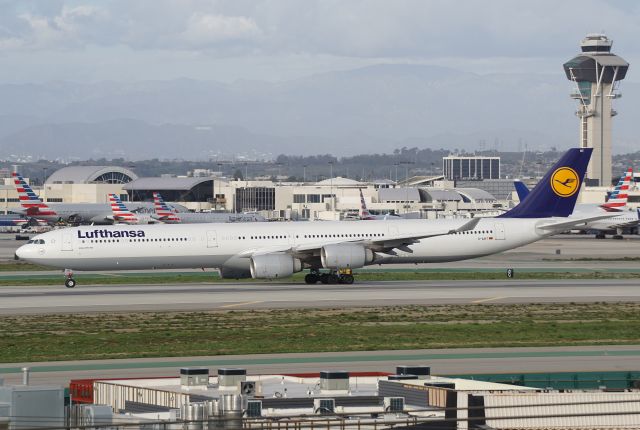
11 172 170 224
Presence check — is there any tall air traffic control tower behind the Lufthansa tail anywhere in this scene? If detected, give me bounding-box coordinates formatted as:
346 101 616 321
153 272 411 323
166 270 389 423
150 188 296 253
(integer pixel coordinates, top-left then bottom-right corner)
563 34 629 186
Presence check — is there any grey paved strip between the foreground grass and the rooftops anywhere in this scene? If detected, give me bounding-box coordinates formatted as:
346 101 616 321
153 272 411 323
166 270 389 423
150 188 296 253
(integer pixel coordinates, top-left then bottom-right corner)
0 345 640 385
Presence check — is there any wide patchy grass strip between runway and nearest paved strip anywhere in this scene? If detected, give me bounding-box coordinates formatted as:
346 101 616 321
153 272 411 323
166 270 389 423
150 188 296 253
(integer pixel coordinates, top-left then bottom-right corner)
0 303 640 363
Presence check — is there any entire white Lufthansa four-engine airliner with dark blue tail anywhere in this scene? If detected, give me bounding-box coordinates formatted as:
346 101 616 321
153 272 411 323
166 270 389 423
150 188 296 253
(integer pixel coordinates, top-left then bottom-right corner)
16 148 611 288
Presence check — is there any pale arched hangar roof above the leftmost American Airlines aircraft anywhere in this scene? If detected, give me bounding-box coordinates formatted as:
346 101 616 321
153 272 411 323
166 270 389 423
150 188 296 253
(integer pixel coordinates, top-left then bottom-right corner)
45 166 138 184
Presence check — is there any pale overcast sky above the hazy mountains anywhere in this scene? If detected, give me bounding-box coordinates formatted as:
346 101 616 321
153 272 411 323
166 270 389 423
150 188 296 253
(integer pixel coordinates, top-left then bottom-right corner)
0 0 640 83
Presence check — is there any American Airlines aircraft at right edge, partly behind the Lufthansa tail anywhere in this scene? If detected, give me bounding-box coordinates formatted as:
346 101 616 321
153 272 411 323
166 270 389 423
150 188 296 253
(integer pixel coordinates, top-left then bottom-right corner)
514 168 640 239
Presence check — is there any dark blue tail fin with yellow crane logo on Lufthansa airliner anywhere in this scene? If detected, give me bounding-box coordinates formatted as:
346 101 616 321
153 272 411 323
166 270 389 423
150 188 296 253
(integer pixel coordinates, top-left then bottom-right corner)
497 148 593 218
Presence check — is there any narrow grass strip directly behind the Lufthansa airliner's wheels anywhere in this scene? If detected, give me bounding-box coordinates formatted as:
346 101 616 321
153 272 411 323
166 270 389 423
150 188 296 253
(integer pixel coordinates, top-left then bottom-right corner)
0 269 640 286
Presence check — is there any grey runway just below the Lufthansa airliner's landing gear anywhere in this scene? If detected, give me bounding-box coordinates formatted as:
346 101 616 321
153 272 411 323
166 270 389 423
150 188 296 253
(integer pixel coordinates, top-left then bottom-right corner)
0 279 640 315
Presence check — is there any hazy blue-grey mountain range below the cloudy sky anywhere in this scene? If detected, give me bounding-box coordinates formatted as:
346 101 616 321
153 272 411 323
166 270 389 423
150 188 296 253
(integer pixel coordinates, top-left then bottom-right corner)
0 65 640 159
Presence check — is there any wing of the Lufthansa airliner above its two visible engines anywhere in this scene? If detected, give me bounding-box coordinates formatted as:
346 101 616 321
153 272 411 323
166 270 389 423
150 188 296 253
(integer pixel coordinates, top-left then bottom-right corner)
238 218 480 260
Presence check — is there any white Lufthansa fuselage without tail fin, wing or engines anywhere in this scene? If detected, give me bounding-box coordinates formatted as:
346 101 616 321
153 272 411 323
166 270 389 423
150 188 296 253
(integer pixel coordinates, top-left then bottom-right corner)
16 218 553 270
